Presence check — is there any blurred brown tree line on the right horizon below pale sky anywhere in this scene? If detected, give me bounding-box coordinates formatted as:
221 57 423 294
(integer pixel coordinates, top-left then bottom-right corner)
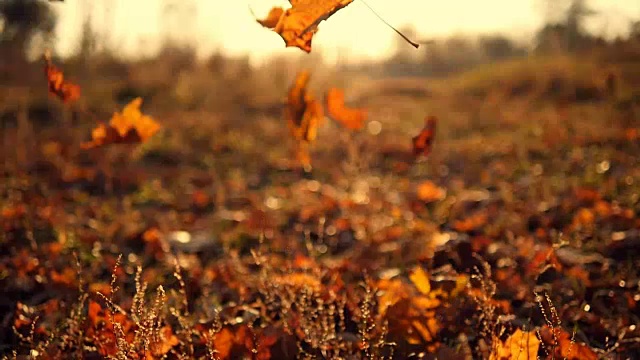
376 0 640 76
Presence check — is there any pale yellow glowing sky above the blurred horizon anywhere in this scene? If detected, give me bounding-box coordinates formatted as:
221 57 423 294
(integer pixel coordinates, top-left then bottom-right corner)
51 0 640 60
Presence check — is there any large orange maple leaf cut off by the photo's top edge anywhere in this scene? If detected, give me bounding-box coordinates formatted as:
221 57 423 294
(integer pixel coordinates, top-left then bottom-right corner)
258 0 353 53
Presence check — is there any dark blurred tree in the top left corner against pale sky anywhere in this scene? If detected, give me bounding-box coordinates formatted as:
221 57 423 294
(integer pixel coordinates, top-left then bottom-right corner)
0 0 56 81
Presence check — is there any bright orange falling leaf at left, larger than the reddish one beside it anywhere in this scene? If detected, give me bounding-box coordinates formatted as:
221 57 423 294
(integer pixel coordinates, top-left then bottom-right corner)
82 97 160 149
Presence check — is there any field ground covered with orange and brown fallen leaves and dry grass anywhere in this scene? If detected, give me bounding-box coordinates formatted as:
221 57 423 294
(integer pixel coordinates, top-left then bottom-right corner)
0 51 640 359
